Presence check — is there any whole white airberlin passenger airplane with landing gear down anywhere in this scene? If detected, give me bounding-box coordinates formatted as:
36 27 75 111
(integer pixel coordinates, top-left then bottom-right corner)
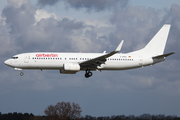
4 24 175 78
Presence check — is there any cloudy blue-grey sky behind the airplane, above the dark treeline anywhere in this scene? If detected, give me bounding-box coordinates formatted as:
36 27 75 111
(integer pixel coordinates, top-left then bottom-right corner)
0 0 180 116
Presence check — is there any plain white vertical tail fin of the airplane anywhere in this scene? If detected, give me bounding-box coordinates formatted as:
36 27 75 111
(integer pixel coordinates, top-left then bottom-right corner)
130 24 171 56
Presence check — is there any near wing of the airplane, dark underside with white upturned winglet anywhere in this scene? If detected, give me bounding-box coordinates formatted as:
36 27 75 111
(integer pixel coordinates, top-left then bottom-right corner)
79 40 124 69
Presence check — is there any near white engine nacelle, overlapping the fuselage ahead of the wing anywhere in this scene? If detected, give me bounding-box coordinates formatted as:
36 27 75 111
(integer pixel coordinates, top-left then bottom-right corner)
63 63 80 72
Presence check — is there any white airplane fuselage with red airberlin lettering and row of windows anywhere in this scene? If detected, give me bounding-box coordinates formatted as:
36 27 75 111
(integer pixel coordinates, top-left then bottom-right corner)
5 52 164 70
